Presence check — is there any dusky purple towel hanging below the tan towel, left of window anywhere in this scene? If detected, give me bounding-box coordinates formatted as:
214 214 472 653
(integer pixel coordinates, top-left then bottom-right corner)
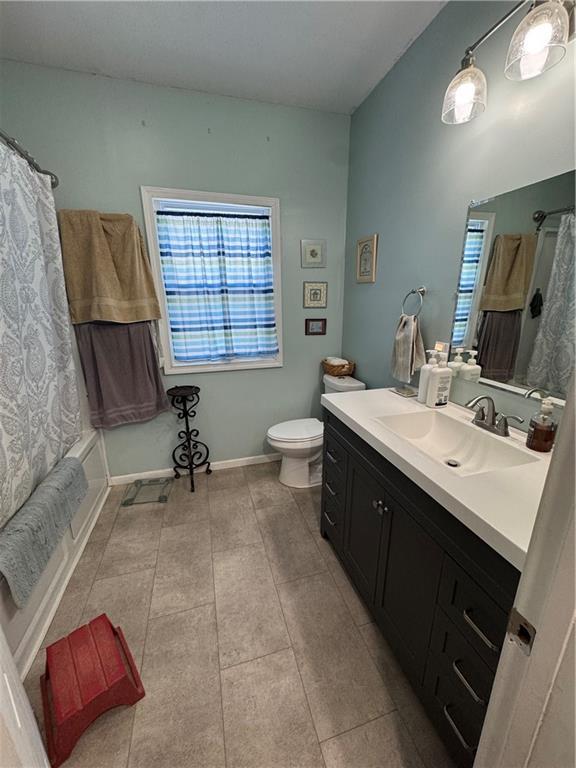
74 322 170 429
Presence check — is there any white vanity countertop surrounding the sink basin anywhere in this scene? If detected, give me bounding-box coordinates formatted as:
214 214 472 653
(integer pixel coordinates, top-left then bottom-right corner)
322 389 551 570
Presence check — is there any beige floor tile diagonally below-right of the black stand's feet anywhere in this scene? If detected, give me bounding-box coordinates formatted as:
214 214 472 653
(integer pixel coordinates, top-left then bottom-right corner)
209 487 262 552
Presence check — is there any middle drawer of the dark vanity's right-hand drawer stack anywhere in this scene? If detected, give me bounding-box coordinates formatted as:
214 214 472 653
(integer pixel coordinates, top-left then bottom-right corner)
430 606 494 716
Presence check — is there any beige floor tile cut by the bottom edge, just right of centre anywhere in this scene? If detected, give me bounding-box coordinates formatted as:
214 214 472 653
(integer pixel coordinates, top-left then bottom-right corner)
322 712 424 768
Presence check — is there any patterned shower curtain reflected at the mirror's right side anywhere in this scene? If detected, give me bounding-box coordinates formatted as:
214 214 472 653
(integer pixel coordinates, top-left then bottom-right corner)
527 213 576 394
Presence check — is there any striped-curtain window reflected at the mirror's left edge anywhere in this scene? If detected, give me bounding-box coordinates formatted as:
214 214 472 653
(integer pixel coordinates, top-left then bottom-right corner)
451 213 494 347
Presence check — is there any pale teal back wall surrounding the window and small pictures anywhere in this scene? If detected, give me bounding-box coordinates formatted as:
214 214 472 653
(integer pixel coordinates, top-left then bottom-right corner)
0 62 350 475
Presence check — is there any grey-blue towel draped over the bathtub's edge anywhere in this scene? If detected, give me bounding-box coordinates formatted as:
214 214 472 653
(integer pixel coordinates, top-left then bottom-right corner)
0 458 88 608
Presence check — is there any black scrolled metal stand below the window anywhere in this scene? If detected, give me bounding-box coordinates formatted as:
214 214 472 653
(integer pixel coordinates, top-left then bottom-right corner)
166 386 212 493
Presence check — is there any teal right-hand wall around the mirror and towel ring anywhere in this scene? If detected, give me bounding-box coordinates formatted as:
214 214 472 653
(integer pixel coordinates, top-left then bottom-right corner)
342 2 575 414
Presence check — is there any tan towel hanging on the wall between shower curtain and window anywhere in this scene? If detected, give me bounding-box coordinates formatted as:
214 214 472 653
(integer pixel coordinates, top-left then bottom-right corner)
58 210 160 325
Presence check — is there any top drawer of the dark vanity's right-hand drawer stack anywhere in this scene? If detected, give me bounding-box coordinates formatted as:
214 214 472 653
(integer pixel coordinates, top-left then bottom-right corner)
438 557 508 670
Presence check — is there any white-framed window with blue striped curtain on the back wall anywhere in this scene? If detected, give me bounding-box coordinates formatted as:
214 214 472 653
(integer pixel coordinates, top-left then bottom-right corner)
142 187 282 374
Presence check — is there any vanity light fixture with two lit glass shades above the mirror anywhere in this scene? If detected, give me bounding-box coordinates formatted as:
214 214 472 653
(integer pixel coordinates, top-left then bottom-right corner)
442 0 574 125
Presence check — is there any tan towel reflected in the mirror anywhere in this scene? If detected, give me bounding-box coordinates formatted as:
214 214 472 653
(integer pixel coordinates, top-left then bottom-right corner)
479 235 538 312
